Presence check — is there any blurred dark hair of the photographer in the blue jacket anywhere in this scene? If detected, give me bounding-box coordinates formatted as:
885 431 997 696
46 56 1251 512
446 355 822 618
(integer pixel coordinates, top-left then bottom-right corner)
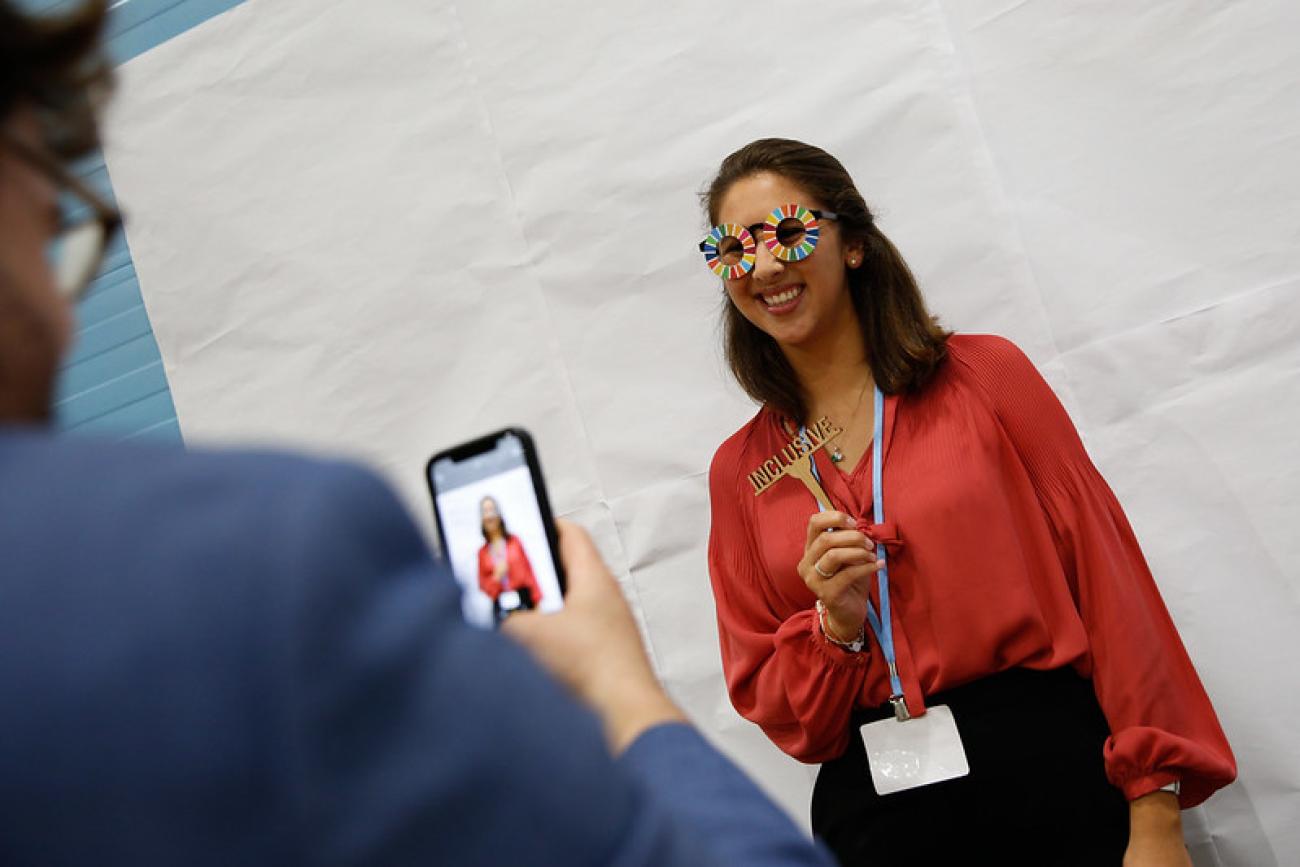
0 0 112 159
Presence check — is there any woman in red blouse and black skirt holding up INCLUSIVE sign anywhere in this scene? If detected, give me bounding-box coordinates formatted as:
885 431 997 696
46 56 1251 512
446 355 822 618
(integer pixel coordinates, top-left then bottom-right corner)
701 139 1236 867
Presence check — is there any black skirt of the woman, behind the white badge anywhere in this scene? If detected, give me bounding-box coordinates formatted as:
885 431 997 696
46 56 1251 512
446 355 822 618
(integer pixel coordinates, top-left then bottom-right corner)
813 668 1128 867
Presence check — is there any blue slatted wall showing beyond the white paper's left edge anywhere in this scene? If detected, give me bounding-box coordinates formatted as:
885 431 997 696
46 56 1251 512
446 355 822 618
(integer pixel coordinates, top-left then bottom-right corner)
23 0 243 442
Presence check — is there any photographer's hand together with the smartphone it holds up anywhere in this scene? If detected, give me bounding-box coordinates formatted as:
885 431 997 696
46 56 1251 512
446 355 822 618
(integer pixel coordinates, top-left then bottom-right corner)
425 428 686 753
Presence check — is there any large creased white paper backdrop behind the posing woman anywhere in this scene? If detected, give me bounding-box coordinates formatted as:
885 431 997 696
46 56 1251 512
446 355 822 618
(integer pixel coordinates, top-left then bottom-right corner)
107 0 1300 867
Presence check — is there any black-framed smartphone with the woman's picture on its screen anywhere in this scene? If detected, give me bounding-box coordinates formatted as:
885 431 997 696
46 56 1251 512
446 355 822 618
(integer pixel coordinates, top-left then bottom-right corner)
425 428 564 629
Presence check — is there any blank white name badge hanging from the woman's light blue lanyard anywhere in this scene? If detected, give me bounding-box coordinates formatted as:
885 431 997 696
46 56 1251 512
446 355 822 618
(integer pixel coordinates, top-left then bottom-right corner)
862 705 971 794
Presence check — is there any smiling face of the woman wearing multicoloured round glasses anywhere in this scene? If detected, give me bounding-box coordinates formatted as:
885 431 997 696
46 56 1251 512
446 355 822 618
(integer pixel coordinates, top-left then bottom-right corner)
718 172 862 347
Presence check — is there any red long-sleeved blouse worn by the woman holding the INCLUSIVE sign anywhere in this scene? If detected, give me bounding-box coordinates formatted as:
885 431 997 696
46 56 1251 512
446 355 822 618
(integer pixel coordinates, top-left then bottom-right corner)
709 335 1236 807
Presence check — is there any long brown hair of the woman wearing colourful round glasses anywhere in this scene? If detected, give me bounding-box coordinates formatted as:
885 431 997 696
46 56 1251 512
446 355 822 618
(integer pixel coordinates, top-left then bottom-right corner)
702 139 949 421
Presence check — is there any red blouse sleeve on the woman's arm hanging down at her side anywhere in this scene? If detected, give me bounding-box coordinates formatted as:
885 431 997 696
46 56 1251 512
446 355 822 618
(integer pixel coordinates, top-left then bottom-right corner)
953 338 1236 809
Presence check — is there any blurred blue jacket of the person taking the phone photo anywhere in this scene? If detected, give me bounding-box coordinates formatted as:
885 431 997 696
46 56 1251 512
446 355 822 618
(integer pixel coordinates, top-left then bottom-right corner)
0 429 831 867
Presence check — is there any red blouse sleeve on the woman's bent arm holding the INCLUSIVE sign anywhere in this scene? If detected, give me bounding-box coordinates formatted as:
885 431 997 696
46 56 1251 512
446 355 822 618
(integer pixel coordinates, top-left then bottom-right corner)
709 441 868 763
